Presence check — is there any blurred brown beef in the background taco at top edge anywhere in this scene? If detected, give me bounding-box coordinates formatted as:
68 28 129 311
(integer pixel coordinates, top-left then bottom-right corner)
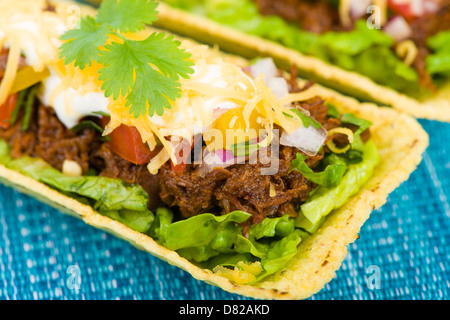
255 0 342 33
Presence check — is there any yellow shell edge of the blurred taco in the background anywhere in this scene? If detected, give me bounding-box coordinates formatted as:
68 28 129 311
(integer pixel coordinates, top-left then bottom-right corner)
154 1 450 122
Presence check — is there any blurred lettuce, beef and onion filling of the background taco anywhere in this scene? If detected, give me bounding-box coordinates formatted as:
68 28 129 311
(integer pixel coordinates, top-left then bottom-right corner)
164 0 450 97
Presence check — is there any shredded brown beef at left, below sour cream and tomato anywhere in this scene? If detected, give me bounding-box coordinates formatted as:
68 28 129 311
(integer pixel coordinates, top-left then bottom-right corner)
0 101 162 210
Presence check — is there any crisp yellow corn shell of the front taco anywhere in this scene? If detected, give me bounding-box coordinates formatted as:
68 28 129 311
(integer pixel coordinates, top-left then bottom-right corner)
0 1 428 299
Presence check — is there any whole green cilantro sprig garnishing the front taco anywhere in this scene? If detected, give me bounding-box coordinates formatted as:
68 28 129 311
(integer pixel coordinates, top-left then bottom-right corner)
60 0 194 118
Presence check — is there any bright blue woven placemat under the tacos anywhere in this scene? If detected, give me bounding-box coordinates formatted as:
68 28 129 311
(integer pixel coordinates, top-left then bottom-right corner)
0 121 450 299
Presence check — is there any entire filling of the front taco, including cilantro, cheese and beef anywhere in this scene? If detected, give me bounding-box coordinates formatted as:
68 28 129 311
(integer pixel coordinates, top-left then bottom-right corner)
0 0 379 283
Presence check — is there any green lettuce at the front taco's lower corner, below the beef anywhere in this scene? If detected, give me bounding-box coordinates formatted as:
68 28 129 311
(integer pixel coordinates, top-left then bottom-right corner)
150 210 302 281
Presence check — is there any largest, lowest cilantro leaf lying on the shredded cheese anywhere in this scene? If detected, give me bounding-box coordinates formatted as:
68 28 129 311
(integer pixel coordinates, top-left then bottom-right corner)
99 33 193 117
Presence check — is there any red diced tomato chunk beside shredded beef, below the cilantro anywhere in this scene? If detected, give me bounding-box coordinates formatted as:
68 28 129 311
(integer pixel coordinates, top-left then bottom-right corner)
101 117 161 164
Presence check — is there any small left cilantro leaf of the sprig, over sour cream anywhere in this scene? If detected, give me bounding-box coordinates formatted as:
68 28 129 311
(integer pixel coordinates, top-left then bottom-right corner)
59 16 110 70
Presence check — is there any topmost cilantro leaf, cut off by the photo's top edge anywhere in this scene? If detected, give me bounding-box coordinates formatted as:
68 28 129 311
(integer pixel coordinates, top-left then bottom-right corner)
97 0 158 32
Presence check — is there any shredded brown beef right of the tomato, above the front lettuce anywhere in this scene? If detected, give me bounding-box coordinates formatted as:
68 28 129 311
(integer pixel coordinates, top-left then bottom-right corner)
158 143 314 230
